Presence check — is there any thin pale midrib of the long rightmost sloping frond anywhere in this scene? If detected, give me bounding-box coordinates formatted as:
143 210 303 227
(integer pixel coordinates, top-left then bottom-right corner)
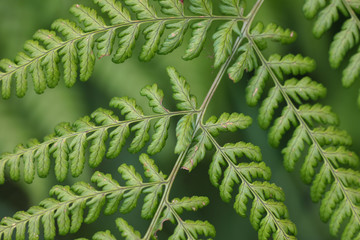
247 34 360 225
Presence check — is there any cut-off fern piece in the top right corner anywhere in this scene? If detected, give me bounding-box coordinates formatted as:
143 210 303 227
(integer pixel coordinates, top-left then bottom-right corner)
303 0 360 106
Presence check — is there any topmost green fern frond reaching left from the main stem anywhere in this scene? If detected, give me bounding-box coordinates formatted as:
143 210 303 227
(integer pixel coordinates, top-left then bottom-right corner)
0 0 246 98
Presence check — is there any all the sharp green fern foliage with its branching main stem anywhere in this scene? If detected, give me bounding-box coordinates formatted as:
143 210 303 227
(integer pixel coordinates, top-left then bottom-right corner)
0 0 360 240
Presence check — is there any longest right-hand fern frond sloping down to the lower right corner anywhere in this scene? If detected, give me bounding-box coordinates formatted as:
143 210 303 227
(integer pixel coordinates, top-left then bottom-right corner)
246 21 360 239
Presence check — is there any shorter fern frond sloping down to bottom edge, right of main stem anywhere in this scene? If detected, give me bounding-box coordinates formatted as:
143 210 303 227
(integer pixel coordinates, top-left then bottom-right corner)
202 128 296 240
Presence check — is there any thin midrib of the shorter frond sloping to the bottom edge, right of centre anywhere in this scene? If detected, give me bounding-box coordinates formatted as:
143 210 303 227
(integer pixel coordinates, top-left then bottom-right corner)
202 126 291 239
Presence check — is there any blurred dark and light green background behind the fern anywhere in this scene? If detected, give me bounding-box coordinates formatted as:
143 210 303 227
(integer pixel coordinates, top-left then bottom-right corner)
0 0 360 240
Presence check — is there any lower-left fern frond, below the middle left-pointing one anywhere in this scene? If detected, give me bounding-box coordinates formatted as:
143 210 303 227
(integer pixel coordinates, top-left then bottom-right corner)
0 156 166 239
